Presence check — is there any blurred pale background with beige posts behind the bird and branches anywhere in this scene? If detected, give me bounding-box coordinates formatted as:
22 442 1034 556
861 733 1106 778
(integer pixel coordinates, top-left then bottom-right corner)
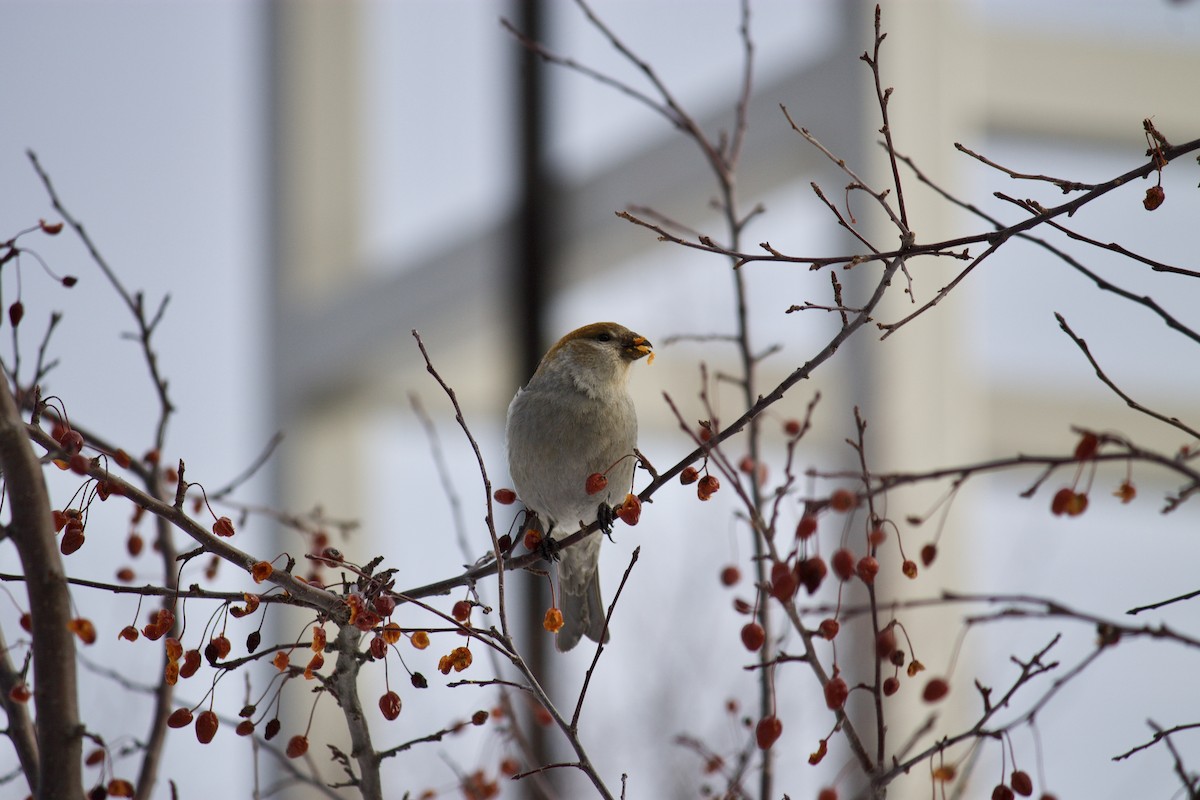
0 0 1200 798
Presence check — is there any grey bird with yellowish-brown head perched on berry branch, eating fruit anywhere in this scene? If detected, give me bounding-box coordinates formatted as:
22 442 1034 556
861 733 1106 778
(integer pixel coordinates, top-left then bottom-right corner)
505 323 652 651
